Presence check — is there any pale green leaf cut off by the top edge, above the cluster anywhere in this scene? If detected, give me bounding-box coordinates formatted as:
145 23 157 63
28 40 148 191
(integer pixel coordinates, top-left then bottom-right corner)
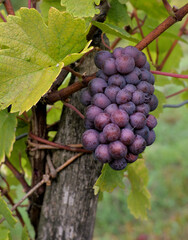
61 0 100 17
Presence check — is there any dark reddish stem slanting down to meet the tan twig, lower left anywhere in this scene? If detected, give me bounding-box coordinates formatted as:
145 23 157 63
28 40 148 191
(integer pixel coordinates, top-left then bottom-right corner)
4 157 30 192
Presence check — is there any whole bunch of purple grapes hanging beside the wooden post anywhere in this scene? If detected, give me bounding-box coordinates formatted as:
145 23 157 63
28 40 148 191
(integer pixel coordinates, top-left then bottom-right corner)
81 46 158 170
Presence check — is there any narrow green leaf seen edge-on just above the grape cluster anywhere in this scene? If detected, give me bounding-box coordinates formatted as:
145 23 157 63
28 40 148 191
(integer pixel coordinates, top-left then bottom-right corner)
92 21 138 43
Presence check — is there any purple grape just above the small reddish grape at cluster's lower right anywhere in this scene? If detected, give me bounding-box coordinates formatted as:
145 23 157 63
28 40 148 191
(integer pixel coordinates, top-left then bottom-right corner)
129 135 146 155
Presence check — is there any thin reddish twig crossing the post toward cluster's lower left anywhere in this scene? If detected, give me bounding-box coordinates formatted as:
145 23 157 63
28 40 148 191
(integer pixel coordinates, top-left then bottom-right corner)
29 132 90 153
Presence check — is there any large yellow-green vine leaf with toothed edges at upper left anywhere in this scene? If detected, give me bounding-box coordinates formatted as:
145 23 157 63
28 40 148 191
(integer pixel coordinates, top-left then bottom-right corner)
0 8 90 113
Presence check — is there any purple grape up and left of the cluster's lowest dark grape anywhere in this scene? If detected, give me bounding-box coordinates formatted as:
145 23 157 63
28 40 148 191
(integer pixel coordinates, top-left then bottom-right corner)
95 144 112 163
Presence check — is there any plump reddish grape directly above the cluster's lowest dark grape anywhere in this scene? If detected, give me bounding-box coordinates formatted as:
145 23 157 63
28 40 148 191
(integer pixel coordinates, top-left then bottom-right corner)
109 141 127 159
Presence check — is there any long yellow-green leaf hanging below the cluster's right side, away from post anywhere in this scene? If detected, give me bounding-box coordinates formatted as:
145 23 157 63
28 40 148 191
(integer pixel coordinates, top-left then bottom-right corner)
127 159 151 219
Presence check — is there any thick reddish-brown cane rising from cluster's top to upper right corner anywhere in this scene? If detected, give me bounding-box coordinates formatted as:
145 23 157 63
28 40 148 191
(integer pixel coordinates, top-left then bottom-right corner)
136 3 188 50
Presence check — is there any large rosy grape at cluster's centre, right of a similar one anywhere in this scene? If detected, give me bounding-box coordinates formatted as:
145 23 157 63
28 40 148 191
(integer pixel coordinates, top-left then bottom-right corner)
111 109 129 127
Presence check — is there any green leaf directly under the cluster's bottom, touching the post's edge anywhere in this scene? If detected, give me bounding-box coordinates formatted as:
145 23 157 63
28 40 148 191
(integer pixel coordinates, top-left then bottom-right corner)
93 164 125 195
